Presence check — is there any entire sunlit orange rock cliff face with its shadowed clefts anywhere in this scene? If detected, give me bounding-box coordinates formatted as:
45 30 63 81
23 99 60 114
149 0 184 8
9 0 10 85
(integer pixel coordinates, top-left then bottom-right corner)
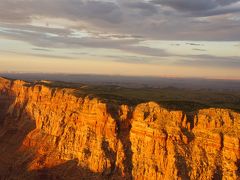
0 79 240 180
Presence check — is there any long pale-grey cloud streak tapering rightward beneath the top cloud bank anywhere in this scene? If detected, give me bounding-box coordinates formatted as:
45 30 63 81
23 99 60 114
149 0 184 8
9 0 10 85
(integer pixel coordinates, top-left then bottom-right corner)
0 23 169 57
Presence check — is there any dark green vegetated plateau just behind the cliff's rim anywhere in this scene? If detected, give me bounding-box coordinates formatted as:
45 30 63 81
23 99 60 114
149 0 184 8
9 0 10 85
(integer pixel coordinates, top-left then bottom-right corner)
26 81 240 112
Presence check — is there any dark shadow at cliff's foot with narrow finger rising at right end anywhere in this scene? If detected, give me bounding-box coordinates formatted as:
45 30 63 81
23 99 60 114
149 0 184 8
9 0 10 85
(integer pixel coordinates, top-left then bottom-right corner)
17 140 126 180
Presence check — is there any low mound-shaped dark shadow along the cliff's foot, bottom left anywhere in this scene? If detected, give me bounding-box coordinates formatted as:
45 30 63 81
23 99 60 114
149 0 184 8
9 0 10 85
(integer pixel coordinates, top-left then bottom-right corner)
3 159 123 180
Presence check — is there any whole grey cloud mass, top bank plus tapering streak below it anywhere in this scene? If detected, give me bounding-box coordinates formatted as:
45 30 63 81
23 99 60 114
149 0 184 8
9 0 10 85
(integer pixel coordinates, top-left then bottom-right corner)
0 0 240 65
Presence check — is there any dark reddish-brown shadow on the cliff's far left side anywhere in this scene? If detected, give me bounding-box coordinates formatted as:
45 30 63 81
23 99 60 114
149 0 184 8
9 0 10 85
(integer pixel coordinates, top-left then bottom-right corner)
0 86 35 180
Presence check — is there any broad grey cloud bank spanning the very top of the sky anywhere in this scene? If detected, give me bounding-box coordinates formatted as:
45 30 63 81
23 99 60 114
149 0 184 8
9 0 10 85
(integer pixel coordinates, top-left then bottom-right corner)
0 0 240 40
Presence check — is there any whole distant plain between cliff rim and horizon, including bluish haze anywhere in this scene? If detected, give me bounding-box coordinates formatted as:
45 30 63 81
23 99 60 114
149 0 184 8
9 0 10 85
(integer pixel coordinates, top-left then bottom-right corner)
0 73 240 112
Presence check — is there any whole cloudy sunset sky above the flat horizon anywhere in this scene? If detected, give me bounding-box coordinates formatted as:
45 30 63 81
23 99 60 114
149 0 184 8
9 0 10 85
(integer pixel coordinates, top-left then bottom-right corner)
0 0 240 79
